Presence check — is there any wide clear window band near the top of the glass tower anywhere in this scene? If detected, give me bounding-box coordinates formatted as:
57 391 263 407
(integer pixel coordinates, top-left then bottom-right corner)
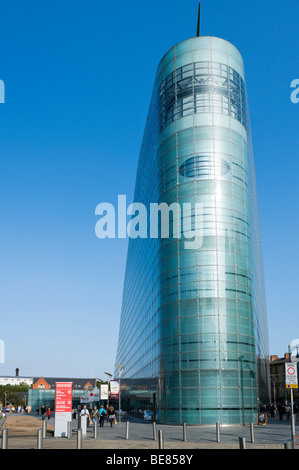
158 62 247 130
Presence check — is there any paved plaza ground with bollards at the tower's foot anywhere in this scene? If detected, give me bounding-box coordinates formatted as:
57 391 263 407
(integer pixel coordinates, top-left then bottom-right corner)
1 414 299 450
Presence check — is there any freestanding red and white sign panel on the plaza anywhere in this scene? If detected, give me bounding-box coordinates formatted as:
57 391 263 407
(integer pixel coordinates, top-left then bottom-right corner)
54 382 73 437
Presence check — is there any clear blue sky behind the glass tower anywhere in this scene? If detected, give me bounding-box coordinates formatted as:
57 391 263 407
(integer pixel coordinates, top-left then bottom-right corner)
0 0 299 377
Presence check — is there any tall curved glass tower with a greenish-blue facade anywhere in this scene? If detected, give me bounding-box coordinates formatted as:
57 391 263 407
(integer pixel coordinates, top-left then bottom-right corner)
116 19 269 424
